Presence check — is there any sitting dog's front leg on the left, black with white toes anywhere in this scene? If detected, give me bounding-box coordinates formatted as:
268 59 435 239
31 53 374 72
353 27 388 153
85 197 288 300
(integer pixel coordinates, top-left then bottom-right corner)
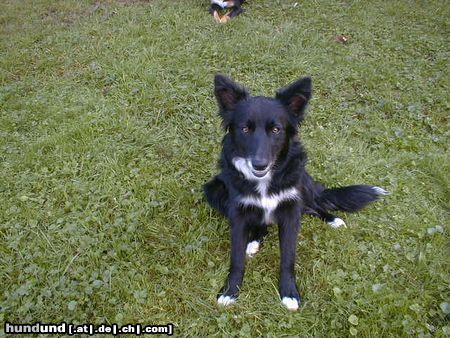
217 216 248 305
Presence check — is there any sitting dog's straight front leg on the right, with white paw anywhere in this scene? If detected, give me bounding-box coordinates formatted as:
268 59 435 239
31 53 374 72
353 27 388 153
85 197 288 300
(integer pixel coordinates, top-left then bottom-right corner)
277 204 300 311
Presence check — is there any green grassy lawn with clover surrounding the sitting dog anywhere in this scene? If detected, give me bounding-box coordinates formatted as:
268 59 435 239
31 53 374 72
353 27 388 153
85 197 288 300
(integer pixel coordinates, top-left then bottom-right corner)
0 0 450 337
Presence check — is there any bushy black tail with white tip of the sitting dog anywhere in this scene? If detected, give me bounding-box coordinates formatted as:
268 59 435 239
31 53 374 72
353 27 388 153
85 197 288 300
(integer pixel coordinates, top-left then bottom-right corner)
318 185 388 212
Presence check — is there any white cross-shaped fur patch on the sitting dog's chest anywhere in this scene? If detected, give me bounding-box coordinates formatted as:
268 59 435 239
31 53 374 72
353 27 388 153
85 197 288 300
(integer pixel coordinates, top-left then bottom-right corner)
240 188 300 224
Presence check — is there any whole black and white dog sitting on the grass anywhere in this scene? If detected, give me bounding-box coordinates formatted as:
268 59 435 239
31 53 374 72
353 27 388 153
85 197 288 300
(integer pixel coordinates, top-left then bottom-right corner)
204 75 387 310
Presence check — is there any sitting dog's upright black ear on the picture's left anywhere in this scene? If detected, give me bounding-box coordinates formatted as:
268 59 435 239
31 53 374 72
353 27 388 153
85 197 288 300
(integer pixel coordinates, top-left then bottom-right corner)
214 74 249 126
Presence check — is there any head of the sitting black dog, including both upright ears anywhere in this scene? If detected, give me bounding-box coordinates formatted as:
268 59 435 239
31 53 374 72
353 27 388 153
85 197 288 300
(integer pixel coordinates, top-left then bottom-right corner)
214 74 312 180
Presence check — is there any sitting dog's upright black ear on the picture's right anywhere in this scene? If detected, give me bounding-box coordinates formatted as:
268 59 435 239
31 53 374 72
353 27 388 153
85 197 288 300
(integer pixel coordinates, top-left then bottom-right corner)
275 77 312 122
